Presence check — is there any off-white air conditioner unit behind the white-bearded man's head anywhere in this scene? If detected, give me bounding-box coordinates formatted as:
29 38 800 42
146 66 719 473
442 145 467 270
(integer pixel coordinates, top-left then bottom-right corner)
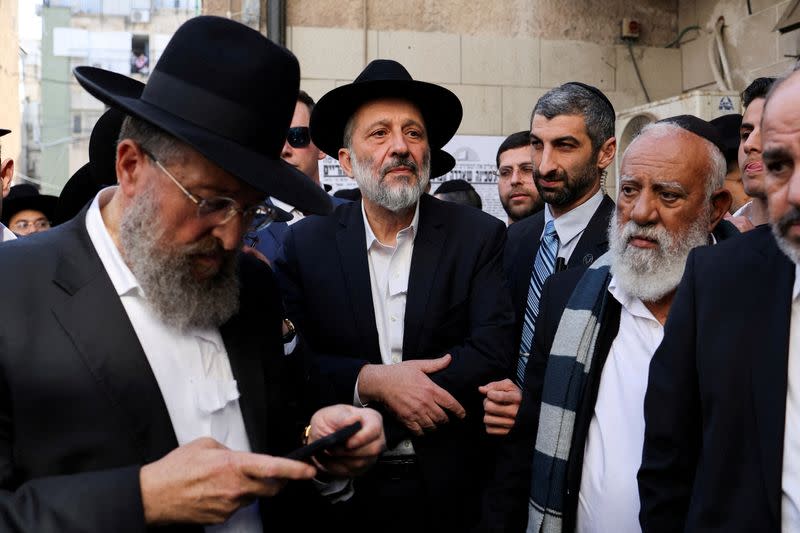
608 90 742 193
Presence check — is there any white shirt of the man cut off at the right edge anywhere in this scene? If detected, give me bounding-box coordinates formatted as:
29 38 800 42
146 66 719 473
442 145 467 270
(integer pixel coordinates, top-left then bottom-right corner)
781 266 800 532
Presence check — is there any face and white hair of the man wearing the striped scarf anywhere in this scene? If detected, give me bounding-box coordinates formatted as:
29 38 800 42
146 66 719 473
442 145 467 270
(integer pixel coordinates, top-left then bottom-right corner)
609 130 730 301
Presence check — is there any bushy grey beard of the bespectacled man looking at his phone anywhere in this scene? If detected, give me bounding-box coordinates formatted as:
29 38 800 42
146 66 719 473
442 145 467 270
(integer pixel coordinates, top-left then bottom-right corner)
119 187 239 331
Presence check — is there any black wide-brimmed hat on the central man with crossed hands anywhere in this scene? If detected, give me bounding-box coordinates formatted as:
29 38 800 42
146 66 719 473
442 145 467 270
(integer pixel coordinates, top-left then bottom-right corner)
311 59 463 158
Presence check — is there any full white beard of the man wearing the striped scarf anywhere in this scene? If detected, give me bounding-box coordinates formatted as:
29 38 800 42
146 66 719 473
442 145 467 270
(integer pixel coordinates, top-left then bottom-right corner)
608 210 711 302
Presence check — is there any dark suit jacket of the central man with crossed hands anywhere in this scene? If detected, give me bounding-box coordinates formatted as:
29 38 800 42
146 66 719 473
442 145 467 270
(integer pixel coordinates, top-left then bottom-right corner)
276 195 513 513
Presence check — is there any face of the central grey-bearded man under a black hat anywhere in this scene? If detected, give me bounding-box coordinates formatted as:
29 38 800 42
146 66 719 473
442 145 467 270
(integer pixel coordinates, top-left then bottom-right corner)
339 99 430 212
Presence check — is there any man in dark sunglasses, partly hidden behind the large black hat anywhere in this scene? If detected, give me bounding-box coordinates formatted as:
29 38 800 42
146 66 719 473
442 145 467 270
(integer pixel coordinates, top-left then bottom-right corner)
254 91 345 261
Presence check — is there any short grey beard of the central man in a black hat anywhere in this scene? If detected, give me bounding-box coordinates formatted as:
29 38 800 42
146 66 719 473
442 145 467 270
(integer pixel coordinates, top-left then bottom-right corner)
350 150 431 213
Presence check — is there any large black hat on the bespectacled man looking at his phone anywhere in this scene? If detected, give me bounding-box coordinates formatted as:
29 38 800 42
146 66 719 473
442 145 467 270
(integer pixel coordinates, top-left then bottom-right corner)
74 16 331 214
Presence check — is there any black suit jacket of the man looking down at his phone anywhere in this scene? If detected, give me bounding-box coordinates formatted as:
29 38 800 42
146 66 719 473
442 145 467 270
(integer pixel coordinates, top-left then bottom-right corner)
0 210 314 532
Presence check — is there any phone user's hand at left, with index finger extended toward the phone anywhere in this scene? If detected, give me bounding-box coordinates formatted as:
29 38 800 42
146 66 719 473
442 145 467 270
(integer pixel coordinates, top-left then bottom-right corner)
139 437 316 525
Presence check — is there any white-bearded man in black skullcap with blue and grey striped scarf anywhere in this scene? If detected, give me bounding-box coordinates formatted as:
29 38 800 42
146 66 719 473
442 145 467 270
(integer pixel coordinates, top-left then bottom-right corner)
478 116 731 533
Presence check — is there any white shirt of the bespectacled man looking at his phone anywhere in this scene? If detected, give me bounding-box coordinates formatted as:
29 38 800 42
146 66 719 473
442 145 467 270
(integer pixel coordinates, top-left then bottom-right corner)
86 188 262 533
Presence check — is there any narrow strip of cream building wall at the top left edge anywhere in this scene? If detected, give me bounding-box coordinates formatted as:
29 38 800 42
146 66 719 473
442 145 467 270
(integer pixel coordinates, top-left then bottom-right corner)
0 0 22 164
